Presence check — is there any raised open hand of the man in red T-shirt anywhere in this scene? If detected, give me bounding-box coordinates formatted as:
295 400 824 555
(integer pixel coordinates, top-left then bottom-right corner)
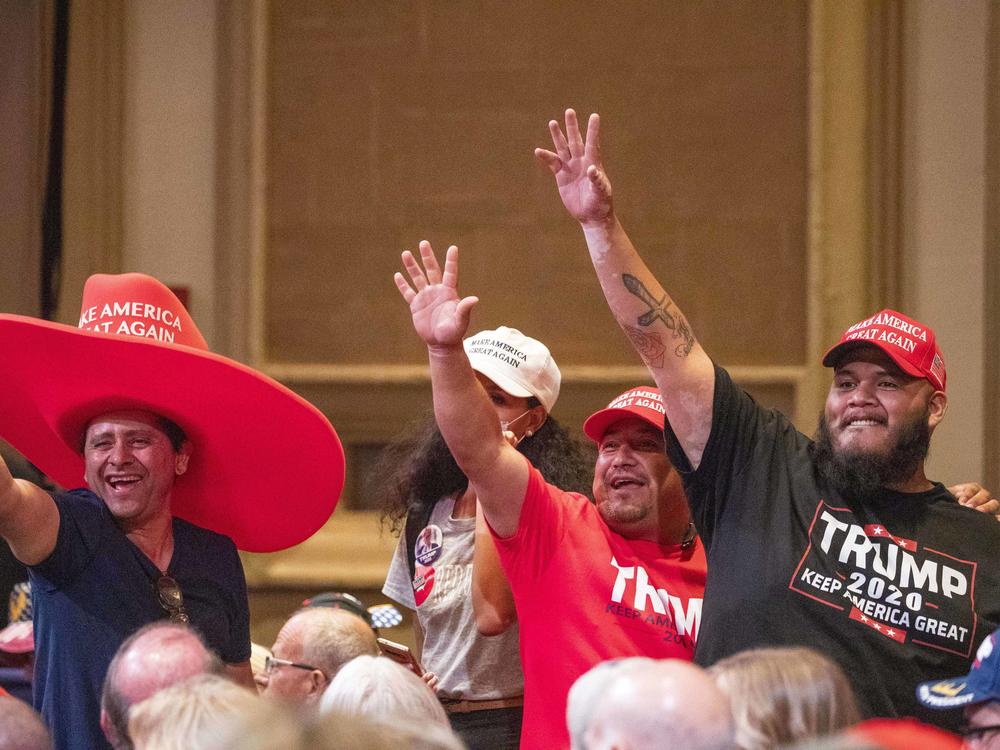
393 240 479 346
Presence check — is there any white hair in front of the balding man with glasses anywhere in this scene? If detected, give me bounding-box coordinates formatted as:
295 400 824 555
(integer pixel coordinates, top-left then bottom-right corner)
320 656 450 726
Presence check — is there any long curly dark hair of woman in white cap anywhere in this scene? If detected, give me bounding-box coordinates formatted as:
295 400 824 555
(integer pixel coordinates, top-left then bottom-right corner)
376 406 594 533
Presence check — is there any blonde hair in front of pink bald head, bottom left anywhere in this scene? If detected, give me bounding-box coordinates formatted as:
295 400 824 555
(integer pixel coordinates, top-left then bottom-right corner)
128 675 260 750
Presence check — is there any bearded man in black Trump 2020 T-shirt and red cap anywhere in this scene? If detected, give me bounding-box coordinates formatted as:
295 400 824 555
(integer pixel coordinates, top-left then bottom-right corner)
535 110 1000 727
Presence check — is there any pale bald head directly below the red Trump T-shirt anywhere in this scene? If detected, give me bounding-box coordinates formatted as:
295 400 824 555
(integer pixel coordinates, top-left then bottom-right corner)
584 659 733 750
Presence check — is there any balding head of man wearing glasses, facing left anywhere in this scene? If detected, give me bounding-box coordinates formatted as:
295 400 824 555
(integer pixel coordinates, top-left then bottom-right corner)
257 607 379 703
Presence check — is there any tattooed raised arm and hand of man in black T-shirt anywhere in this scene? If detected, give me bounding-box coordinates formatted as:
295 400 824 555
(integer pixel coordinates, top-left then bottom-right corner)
535 109 715 467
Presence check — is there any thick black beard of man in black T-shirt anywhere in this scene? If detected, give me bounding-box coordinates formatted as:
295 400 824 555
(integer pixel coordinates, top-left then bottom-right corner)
810 407 931 501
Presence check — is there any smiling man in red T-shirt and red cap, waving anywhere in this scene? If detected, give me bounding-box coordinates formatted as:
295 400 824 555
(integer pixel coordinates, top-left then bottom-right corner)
395 242 705 750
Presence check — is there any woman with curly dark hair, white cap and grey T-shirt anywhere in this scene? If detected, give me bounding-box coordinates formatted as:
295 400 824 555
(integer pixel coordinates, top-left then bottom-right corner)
379 327 593 750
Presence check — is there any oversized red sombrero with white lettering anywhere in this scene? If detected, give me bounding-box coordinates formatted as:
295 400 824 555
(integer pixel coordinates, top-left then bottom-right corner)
0 273 344 552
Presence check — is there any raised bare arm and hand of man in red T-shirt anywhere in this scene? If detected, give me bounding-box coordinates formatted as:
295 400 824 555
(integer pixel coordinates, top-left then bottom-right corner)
394 242 528 537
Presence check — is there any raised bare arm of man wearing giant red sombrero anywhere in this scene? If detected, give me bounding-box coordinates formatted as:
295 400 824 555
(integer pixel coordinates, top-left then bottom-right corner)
0 458 59 565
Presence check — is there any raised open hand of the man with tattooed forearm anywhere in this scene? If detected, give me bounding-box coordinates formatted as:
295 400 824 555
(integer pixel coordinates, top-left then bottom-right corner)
535 109 612 224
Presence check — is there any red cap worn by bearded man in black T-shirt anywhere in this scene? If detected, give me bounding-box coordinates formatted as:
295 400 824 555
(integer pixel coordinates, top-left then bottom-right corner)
823 310 947 391
